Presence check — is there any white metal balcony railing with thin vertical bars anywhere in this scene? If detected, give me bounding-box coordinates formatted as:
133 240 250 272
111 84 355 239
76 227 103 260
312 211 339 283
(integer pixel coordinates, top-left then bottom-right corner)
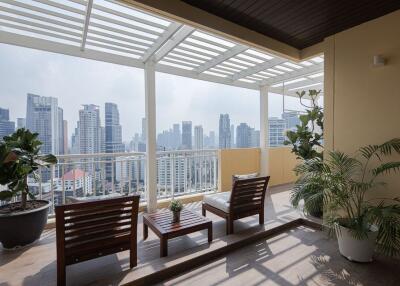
23 150 218 213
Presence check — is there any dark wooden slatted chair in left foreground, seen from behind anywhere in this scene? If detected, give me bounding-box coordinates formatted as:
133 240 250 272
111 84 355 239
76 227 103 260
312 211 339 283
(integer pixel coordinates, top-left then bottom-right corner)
55 195 139 286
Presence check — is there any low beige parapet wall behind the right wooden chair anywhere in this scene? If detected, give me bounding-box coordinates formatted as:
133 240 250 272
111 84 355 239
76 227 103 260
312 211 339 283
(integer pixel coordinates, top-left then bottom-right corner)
218 147 297 191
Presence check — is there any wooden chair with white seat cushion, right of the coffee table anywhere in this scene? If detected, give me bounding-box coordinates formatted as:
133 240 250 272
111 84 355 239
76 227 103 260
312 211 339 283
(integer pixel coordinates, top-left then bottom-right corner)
202 176 269 234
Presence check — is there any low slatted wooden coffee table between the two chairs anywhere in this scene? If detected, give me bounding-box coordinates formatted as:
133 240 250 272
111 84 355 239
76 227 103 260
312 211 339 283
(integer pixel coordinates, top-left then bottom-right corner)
143 209 212 257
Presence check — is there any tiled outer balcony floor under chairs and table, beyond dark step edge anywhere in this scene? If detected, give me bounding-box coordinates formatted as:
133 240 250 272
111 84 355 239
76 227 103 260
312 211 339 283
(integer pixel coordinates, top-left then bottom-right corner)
0 186 308 286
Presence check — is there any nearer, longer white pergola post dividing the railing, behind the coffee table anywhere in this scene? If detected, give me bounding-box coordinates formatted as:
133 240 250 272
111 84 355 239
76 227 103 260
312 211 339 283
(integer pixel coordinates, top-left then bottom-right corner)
144 59 157 213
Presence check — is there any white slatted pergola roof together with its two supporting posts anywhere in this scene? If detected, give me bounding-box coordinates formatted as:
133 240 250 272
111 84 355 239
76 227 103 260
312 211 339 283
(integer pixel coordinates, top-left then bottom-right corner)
0 0 323 211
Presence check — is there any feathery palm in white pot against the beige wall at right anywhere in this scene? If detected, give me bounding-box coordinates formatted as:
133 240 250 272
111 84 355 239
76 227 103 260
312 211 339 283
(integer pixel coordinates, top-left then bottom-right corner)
303 138 400 262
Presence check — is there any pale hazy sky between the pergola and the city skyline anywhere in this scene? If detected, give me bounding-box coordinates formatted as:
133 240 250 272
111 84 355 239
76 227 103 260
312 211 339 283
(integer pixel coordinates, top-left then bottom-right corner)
0 44 297 141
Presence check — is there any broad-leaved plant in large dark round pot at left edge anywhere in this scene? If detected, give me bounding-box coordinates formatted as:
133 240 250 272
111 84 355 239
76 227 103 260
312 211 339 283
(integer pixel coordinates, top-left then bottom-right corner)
0 128 57 249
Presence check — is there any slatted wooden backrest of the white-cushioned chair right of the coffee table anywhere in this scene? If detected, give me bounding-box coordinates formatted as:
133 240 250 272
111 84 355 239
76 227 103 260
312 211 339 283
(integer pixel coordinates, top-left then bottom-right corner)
230 176 269 213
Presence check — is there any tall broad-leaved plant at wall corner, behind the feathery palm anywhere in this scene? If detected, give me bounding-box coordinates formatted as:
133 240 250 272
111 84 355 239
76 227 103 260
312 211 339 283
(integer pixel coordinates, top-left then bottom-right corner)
284 90 324 217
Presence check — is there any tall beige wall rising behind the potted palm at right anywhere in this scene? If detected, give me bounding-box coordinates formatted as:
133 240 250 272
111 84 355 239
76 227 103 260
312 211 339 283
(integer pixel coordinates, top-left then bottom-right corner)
325 11 400 196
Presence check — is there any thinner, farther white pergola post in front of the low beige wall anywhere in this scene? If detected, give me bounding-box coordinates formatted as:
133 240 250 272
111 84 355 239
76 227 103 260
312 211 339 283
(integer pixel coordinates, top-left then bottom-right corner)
260 85 269 176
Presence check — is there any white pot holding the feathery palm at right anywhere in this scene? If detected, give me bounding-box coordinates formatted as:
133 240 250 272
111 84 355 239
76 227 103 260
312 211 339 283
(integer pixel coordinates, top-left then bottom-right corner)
337 226 378 262
